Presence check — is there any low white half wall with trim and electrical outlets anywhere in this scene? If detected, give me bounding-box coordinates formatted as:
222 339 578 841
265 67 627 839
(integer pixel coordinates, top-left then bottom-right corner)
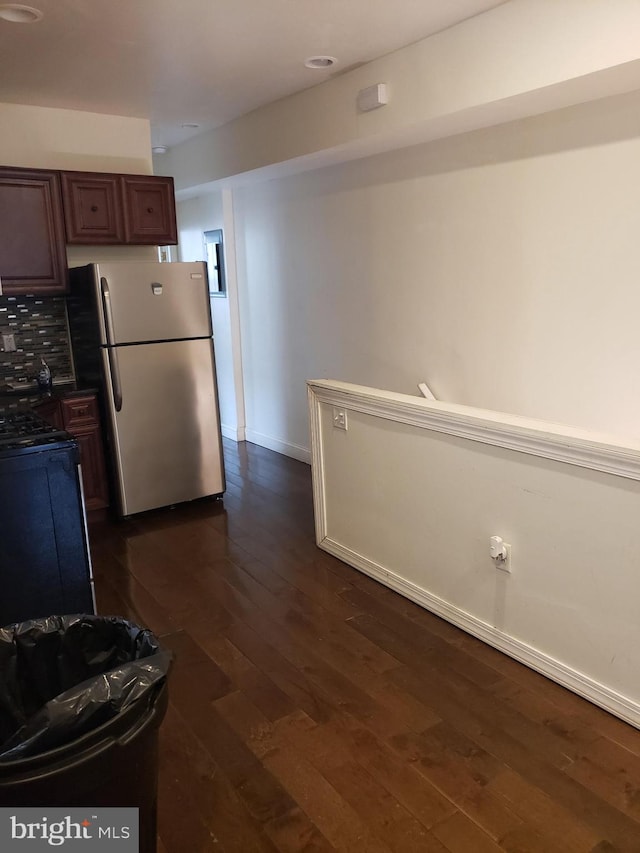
308 380 640 727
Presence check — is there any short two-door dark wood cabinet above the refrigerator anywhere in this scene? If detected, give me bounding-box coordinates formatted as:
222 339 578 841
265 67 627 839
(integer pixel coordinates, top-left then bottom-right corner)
62 172 178 246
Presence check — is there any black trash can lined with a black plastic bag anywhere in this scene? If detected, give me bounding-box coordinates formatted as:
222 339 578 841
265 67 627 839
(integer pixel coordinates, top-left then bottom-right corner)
0 615 171 853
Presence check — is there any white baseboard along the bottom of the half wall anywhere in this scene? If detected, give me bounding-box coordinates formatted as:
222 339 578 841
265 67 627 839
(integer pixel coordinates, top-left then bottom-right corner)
319 537 640 728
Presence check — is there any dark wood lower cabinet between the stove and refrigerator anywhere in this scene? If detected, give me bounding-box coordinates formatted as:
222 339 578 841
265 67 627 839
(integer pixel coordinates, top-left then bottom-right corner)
36 392 109 518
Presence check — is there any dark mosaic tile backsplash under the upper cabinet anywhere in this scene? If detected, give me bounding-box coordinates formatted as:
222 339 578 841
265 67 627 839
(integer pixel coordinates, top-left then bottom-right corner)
0 296 73 384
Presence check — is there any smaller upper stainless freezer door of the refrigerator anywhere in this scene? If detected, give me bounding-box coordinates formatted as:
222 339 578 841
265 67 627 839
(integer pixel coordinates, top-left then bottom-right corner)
93 261 212 345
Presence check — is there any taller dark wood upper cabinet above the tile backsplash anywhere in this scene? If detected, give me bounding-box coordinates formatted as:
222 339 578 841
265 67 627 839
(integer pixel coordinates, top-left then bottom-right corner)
0 167 67 296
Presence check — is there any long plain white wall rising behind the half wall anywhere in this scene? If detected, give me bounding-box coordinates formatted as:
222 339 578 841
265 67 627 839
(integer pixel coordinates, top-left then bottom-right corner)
236 93 640 456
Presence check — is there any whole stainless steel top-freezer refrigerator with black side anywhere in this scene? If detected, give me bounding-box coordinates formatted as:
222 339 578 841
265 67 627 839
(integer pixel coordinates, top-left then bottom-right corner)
67 261 225 516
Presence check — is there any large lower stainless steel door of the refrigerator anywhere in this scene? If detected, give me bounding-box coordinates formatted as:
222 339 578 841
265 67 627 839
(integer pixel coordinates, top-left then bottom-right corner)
103 339 224 515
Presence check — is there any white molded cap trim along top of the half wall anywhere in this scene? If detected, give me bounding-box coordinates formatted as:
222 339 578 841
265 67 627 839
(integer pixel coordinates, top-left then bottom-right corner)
308 380 640 480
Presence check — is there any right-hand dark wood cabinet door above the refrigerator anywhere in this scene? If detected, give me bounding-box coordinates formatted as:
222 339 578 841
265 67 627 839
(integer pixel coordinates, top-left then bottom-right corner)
122 175 178 246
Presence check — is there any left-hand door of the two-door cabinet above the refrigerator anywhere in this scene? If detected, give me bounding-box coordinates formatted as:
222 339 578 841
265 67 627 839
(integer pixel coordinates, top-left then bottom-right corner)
60 172 125 244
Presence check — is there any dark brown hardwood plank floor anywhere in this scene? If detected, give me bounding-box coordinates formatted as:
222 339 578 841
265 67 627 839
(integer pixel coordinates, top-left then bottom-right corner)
91 442 640 853
